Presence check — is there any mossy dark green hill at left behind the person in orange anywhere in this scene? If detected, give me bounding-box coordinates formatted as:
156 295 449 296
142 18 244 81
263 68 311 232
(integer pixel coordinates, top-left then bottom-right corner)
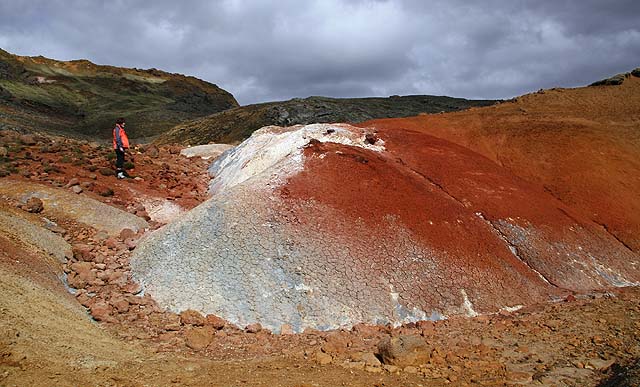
0 50 238 139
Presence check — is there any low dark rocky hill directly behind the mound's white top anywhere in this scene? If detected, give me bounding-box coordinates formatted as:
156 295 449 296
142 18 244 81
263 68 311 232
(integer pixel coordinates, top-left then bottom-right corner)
157 95 496 145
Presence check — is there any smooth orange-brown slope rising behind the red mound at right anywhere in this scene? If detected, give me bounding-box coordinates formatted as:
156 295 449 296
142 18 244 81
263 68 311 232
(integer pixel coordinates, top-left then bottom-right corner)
360 77 640 253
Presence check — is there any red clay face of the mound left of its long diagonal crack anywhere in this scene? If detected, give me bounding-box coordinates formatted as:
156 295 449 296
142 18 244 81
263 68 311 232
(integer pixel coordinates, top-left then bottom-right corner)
281 141 560 311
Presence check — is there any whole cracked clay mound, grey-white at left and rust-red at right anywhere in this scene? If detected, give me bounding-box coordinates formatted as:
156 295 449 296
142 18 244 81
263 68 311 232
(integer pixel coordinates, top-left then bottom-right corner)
131 124 640 332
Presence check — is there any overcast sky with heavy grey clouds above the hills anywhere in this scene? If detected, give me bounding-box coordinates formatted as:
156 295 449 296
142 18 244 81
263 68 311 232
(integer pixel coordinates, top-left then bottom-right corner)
0 0 640 105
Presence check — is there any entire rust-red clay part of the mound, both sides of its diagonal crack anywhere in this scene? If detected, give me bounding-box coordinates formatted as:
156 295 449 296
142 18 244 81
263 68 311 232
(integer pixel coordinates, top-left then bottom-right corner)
281 129 640 304
